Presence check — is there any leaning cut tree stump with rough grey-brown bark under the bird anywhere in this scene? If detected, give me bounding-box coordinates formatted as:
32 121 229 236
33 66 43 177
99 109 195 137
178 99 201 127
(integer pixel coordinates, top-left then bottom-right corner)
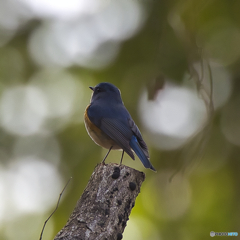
54 164 145 240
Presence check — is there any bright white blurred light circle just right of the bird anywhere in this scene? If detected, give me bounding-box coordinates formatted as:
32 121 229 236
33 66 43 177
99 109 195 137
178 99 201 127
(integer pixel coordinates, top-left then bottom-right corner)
139 83 207 149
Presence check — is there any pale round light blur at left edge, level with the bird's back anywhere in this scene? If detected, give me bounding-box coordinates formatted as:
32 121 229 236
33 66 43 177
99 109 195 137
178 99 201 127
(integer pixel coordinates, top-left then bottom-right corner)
0 86 47 135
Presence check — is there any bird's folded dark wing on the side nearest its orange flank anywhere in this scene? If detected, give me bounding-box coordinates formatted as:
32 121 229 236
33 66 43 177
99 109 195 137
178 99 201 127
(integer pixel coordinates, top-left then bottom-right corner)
100 118 135 160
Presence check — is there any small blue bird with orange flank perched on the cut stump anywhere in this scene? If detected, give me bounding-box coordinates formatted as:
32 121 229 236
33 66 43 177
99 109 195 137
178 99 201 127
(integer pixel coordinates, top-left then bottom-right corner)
84 82 156 171
